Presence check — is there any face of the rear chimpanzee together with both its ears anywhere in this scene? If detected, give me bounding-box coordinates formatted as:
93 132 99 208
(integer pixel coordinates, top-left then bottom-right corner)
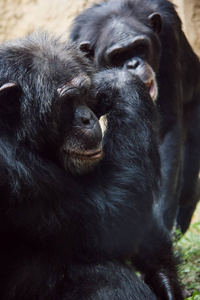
79 13 161 100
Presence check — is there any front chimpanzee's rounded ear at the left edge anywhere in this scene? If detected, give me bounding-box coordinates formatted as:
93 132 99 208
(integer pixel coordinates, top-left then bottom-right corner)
0 82 22 114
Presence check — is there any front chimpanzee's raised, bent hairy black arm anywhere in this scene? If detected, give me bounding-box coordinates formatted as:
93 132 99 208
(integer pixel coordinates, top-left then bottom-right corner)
85 70 160 255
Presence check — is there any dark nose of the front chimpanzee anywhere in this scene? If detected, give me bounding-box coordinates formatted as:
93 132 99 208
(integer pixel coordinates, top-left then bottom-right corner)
73 106 97 129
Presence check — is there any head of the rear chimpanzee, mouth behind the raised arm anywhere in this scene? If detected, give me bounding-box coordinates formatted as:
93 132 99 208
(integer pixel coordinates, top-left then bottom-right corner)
71 0 161 100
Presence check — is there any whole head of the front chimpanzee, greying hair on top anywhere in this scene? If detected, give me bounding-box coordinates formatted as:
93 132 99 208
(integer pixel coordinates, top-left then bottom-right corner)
0 33 102 175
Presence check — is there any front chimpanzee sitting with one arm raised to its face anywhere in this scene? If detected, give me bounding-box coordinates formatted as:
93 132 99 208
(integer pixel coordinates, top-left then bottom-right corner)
0 34 182 300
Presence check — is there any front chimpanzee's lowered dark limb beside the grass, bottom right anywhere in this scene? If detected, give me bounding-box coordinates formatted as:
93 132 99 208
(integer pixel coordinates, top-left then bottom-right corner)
132 202 183 300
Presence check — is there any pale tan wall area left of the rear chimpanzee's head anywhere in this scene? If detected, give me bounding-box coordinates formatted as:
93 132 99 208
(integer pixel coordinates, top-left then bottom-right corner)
0 0 95 41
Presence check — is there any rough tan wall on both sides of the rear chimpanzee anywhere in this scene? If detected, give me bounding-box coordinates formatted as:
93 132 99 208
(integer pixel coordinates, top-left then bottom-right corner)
0 0 200 56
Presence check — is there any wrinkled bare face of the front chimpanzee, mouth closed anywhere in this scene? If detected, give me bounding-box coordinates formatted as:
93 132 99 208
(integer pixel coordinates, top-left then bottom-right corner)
58 75 103 174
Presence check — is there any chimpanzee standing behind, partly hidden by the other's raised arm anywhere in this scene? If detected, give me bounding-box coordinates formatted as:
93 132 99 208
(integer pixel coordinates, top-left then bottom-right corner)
71 0 200 233
